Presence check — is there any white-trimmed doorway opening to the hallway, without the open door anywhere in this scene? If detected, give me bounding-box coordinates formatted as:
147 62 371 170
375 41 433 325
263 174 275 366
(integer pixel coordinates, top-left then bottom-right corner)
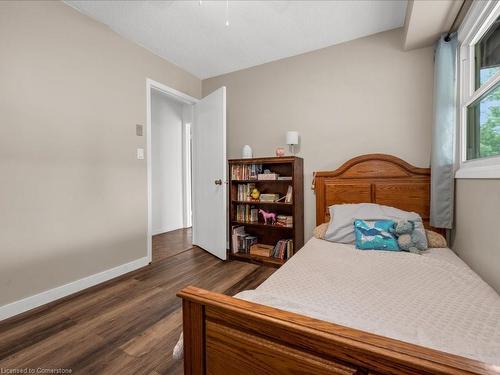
146 79 197 262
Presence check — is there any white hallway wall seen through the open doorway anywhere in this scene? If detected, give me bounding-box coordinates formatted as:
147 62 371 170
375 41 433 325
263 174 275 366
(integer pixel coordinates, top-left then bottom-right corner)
151 90 184 234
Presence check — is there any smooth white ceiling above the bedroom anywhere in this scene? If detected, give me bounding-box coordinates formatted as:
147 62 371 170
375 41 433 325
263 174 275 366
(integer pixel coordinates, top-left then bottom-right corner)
66 0 407 79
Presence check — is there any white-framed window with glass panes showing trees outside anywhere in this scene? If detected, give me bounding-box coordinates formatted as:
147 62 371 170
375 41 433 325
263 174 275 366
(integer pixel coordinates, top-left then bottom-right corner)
457 1 500 178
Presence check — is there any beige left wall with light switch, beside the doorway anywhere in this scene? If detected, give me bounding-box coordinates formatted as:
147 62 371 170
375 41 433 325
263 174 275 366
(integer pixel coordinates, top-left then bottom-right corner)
0 1 201 315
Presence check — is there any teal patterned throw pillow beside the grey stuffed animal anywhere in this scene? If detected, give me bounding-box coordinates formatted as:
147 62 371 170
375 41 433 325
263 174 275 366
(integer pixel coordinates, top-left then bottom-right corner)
354 219 400 251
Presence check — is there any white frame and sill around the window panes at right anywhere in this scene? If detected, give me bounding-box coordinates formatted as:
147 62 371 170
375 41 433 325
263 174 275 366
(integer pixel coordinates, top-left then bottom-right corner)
455 0 500 178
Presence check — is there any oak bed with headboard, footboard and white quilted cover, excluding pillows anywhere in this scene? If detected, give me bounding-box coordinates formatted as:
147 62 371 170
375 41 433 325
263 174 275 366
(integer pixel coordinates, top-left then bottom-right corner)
178 154 500 374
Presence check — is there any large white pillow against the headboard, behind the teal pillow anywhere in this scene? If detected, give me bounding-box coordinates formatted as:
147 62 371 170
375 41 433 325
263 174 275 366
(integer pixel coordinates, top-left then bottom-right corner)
324 203 427 248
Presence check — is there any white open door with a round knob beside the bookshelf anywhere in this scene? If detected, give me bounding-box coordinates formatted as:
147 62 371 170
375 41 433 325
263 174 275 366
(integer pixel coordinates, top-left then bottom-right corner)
192 87 227 260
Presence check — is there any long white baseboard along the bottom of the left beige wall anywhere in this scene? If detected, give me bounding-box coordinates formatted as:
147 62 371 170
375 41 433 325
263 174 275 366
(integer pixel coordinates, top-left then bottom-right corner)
0 257 149 321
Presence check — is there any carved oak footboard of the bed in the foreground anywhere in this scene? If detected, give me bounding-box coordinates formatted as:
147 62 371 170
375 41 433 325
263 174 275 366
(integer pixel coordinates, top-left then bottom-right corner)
178 287 500 375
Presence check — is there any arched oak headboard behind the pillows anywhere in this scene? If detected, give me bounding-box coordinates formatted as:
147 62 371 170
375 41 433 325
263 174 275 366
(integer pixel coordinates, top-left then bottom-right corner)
314 154 431 231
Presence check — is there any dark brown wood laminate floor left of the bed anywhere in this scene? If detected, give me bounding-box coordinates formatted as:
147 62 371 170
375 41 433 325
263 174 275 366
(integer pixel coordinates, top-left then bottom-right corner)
0 229 275 374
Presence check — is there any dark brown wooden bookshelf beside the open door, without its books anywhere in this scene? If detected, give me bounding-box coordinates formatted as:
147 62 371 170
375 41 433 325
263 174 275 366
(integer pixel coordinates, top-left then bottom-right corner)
228 157 304 267
